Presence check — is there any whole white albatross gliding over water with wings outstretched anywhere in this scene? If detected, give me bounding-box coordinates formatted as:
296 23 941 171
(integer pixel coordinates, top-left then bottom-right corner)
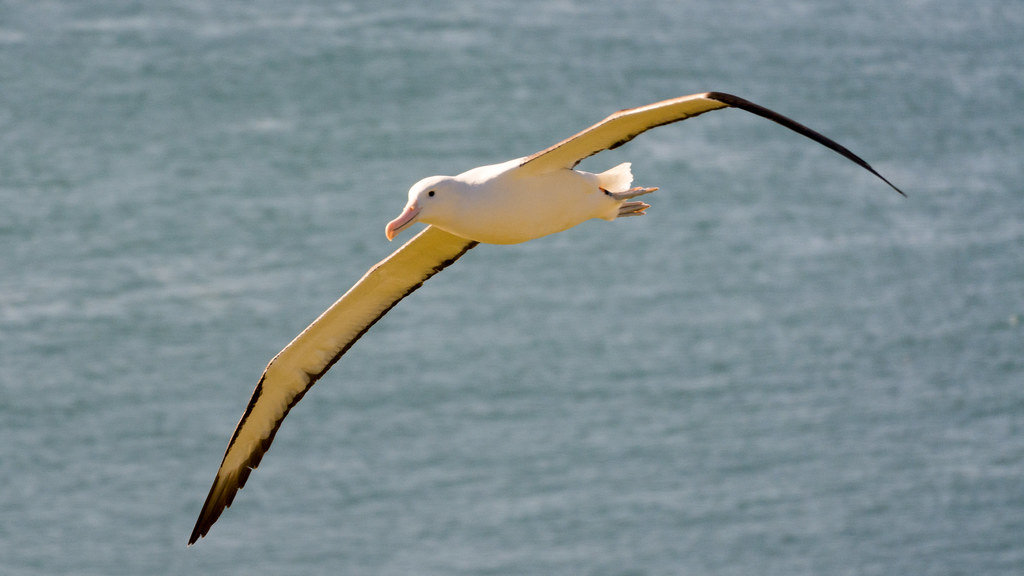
188 92 905 545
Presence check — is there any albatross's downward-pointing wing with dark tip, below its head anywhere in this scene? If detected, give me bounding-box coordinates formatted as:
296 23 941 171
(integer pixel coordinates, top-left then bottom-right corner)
188 227 477 544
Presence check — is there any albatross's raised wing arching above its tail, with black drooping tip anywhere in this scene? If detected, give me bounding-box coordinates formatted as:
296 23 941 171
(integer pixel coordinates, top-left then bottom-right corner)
520 92 905 196
